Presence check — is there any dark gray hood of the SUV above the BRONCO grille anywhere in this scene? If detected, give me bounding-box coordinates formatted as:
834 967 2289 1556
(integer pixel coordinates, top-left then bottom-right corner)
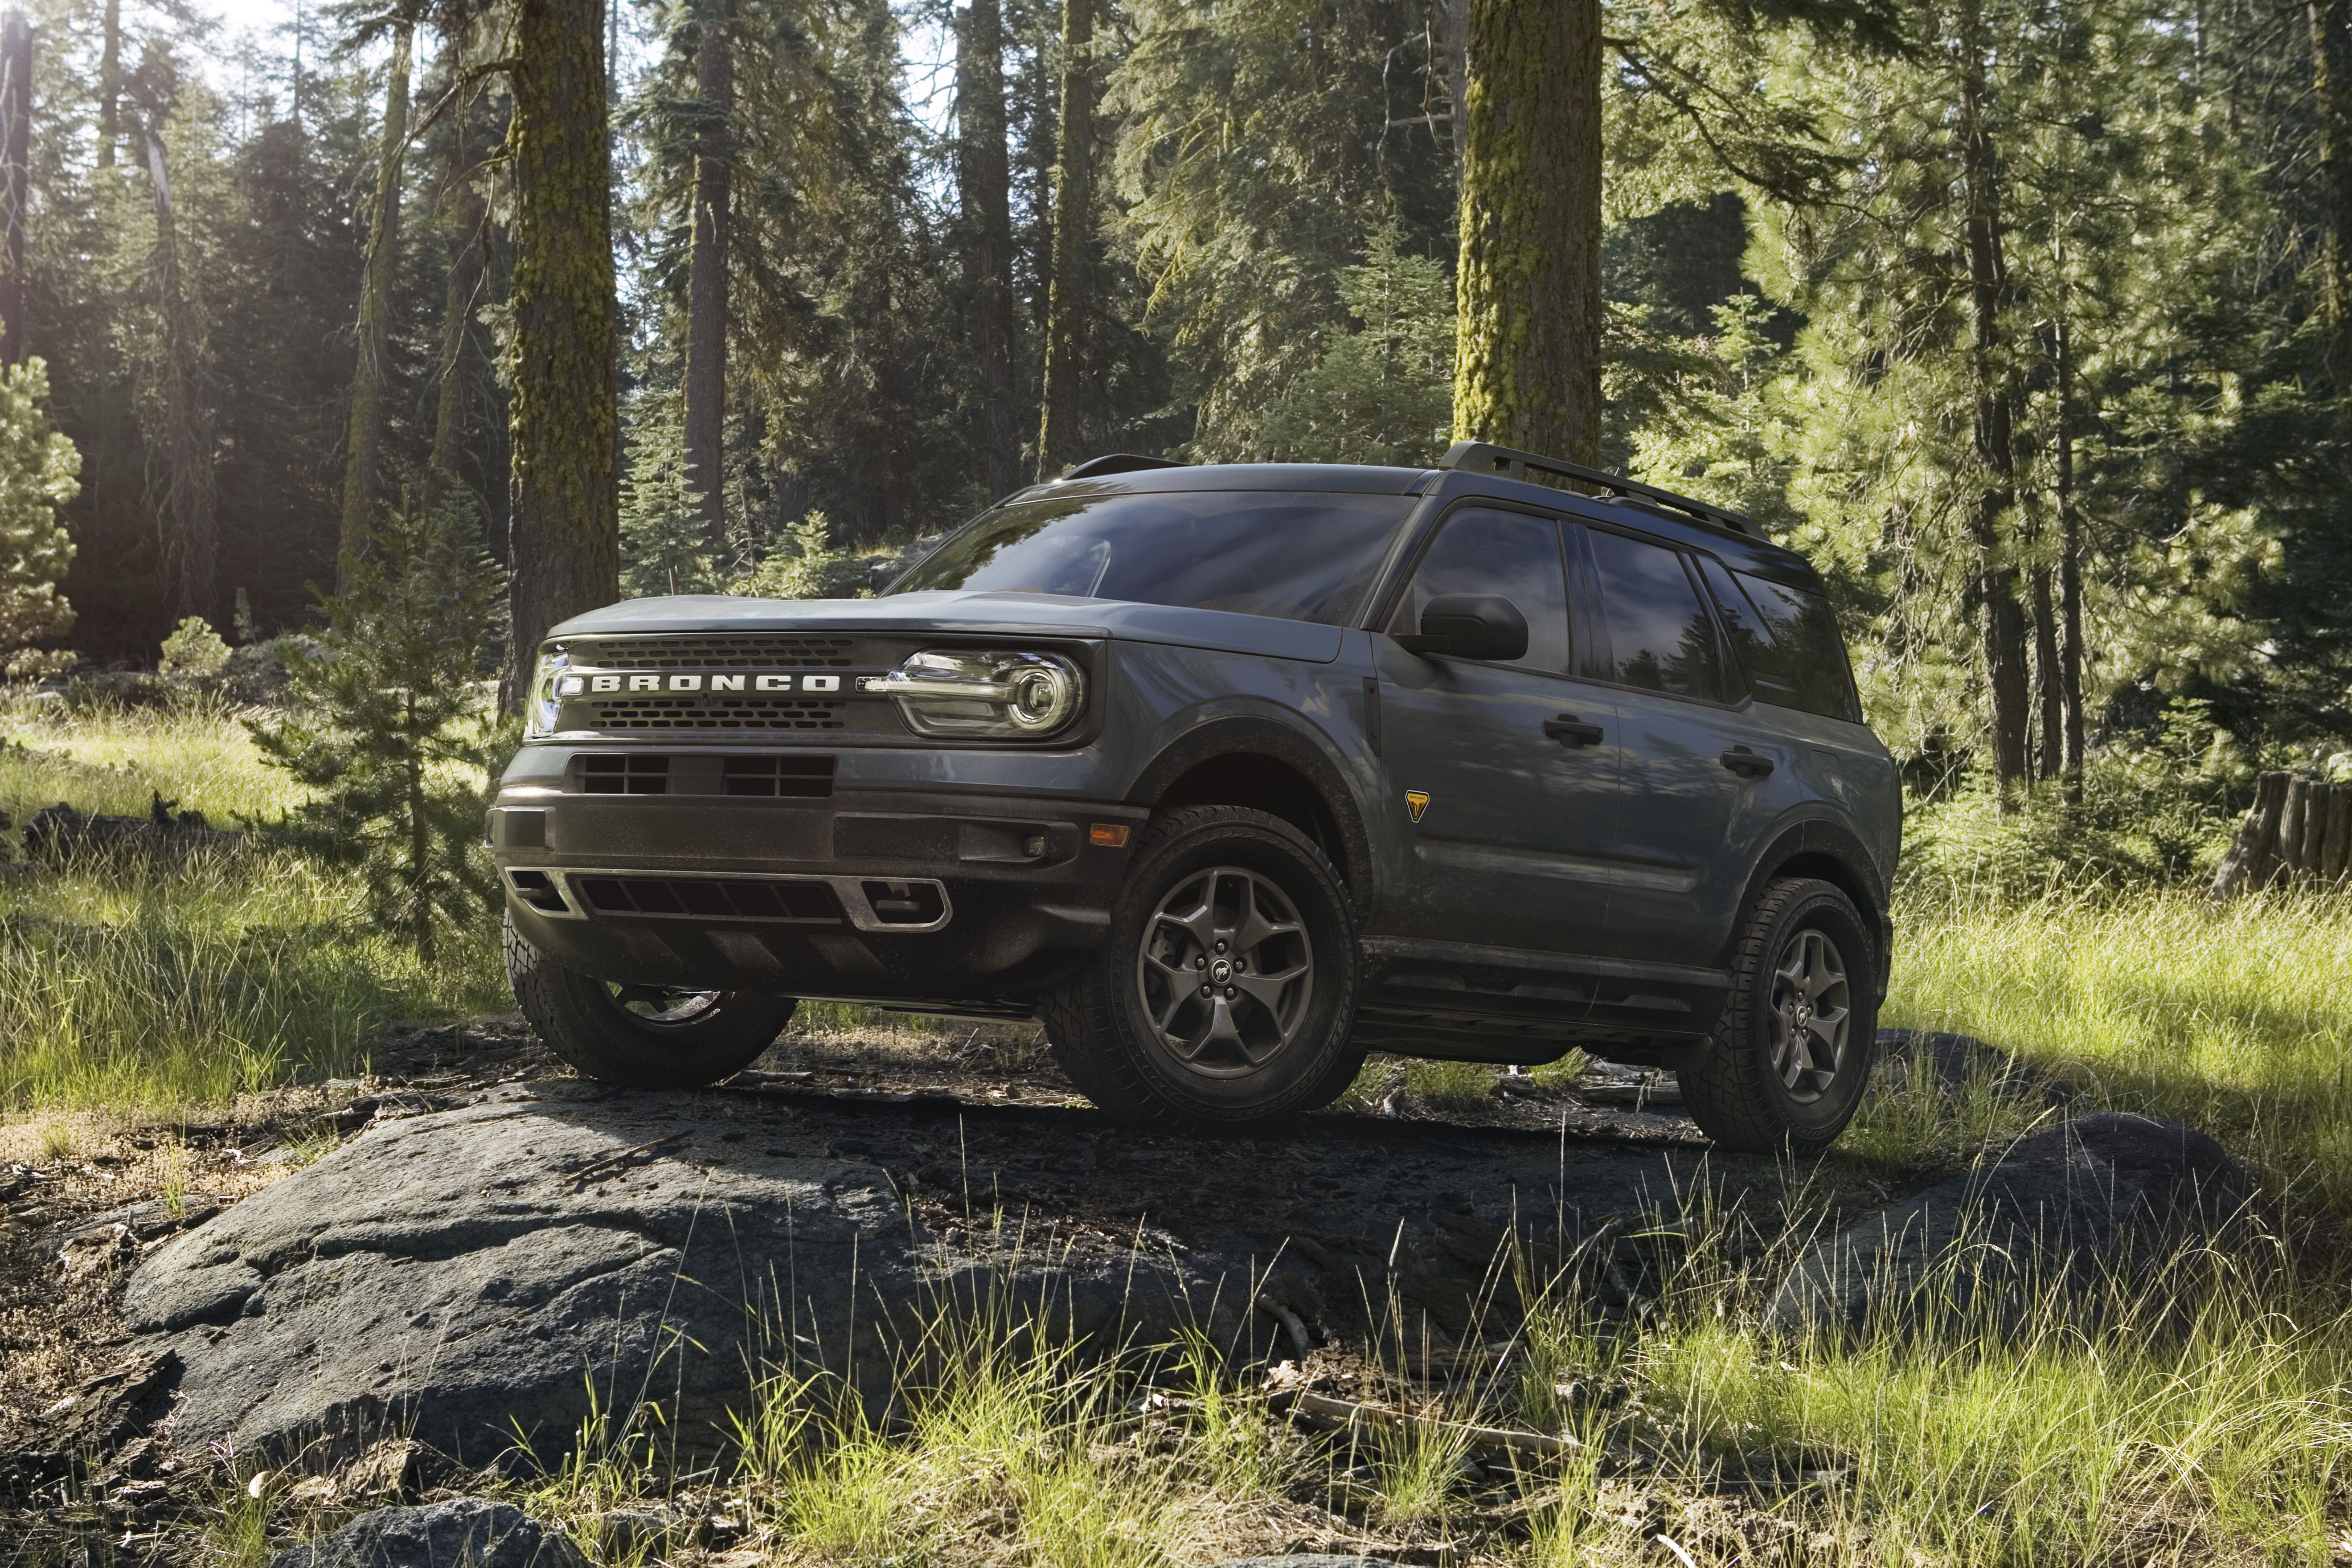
548 590 1345 663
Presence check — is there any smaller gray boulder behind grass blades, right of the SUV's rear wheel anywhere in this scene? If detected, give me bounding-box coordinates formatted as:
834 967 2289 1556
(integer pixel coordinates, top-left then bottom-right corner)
1769 1112 2253 1335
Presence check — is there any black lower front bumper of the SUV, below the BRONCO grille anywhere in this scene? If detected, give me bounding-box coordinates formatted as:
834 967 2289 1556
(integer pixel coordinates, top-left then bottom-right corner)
489 790 1145 1013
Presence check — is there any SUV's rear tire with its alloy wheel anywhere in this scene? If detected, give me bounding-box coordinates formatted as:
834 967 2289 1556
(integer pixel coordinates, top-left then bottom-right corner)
1679 877 1879 1154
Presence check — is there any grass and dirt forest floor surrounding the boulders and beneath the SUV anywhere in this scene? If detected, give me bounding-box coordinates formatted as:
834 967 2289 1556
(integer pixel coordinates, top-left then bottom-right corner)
0 703 2352 1568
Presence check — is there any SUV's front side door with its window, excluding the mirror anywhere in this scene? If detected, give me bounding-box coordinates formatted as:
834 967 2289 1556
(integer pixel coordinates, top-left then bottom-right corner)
1376 508 1618 952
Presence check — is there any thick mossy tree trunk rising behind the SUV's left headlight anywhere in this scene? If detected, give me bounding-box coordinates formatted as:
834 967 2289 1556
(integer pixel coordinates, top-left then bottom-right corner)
508 0 621 703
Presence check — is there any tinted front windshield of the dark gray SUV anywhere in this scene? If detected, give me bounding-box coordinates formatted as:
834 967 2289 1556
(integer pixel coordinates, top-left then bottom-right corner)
891 489 1414 625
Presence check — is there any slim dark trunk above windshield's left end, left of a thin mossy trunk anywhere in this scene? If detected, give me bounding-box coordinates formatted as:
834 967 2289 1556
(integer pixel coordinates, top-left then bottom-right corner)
955 0 1021 501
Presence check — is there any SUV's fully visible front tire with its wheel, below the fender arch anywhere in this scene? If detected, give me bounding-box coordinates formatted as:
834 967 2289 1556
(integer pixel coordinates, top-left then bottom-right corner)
1037 807 1364 1128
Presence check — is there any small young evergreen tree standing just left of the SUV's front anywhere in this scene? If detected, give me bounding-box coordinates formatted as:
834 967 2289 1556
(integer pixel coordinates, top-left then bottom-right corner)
249 505 510 964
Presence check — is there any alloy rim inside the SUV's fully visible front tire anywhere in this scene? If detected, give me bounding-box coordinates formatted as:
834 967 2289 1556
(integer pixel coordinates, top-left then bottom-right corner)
1136 865 1315 1077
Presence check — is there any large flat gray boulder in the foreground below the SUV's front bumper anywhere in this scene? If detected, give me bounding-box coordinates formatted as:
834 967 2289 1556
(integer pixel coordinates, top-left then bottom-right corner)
125 1081 1246 1467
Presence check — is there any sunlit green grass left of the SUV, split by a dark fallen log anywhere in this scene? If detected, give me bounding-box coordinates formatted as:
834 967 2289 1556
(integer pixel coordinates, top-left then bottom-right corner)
0 703 510 1109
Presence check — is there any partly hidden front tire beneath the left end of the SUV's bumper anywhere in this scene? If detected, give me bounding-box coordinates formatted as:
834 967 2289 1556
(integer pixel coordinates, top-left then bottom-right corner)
506 919 797 1089
